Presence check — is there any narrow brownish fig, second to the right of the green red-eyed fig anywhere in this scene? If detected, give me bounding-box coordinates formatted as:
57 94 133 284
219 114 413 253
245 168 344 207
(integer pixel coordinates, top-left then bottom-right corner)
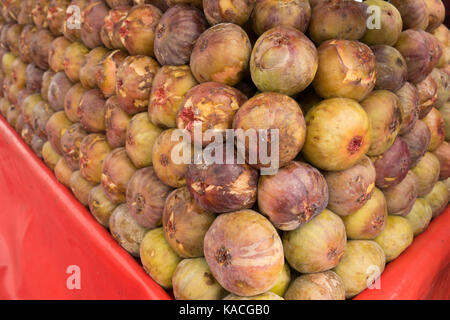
395 82 420 134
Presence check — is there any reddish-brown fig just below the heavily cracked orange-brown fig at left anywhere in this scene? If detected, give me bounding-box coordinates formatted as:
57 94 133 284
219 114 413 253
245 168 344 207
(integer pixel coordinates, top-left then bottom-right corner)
105 96 131 148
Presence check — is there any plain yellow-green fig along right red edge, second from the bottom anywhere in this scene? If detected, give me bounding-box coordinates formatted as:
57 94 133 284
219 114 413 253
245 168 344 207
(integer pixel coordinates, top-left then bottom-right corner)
375 216 414 262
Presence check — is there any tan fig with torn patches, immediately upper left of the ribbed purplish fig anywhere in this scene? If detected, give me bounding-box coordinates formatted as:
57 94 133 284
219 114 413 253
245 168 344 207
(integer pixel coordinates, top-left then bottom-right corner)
101 148 137 204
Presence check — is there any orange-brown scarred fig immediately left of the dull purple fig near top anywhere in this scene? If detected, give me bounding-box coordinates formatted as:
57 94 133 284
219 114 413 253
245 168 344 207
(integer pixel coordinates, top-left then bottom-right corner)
119 4 162 57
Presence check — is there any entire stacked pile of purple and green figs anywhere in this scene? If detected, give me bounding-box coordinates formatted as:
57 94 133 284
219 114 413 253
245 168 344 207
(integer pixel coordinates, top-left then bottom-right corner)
0 0 450 300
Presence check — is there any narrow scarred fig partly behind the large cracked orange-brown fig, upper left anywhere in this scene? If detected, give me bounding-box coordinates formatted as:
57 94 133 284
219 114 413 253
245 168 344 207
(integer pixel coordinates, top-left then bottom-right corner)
95 50 127 97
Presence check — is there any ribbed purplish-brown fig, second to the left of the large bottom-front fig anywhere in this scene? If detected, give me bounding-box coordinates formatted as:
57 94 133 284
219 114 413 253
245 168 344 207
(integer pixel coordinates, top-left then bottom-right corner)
126 167 172 229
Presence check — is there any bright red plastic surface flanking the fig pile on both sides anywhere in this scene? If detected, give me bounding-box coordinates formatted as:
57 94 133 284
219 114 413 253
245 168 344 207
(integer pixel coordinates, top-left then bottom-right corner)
0 116 450 299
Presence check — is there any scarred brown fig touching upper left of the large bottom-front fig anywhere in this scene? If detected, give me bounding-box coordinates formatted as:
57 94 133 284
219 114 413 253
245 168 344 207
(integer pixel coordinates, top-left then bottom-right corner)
162 187 215 258
